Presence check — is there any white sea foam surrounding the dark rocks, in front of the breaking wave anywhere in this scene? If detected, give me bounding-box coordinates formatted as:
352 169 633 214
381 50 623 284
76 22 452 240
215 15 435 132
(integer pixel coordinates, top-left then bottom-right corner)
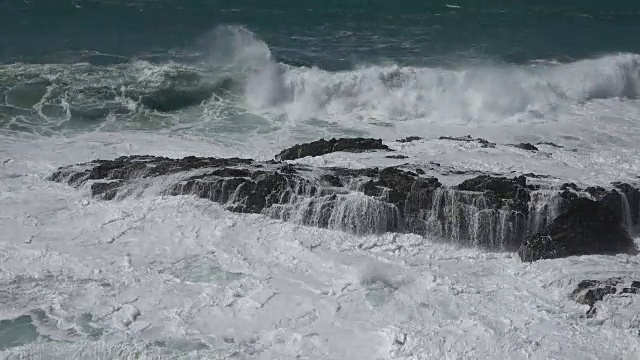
0 124 640 359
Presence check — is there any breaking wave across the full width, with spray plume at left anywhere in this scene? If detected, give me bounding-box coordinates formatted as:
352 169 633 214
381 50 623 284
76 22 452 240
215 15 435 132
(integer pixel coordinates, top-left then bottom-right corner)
0 26 640 134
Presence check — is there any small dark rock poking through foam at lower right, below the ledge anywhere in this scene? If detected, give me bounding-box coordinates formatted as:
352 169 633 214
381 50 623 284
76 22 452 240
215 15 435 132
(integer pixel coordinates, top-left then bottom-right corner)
570 277 640 317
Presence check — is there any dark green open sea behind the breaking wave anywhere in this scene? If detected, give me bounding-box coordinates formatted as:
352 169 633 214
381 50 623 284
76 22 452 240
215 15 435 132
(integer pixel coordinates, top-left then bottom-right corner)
0 0 640 69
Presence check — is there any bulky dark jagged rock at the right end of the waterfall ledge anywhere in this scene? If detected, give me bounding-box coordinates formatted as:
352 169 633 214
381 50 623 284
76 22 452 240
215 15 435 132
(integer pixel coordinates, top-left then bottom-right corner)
518 191 637 261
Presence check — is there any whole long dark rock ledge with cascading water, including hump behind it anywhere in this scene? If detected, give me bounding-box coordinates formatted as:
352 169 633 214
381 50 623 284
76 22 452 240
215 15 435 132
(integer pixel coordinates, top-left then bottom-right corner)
49 138 640 261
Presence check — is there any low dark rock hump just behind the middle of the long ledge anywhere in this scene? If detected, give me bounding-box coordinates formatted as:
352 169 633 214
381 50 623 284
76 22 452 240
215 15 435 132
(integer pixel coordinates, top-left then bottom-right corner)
276 138 391 160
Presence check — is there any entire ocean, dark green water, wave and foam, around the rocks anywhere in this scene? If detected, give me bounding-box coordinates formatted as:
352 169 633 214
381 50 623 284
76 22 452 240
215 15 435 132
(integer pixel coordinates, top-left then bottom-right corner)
0 0 640 359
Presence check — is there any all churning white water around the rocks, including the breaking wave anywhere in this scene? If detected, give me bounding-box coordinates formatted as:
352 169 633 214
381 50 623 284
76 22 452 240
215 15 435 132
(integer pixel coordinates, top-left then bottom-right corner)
0 26 640 359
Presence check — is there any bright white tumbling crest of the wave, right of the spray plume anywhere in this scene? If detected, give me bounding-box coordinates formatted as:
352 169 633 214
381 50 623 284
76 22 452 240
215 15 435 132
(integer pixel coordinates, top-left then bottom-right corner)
246 54 640 122
